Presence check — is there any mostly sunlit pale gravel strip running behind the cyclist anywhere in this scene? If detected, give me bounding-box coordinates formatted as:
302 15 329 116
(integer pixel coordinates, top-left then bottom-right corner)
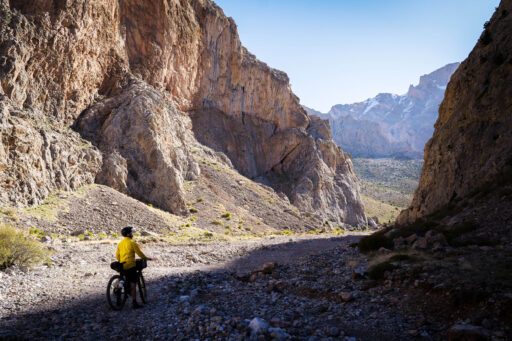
0 235 359 320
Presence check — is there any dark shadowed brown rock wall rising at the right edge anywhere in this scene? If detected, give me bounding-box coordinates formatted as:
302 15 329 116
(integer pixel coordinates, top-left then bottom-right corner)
398 1 512 224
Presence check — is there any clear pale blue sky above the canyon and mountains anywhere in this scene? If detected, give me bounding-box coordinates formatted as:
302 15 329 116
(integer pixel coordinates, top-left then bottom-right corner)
215 0 499 112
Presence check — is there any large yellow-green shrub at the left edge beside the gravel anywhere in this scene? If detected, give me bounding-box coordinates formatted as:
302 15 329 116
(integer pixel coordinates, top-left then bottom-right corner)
0 225 48 269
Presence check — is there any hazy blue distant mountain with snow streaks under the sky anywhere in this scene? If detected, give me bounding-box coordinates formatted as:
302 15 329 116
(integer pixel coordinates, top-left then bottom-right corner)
304 63 459 158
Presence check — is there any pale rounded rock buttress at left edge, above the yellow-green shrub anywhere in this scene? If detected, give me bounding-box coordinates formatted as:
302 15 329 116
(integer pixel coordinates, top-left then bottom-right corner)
0 95 101 206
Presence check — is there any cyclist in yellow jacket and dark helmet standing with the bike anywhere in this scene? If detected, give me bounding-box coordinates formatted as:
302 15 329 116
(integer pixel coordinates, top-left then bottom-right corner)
116 226 151 309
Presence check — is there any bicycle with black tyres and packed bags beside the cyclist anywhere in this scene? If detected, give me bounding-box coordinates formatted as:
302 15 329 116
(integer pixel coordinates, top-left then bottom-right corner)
107 259 148 310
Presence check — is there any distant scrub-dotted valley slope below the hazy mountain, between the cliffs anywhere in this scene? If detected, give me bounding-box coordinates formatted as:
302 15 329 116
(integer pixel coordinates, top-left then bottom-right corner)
353 158 423 223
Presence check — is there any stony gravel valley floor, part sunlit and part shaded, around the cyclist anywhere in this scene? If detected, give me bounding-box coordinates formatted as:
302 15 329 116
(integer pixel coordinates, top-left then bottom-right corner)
0 231 510 340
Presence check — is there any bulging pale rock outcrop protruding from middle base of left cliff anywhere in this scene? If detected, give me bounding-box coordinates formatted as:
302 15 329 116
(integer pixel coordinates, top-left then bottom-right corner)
77 82 199 213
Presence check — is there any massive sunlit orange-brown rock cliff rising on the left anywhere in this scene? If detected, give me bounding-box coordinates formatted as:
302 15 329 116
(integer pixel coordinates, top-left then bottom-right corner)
0 0 367 225
